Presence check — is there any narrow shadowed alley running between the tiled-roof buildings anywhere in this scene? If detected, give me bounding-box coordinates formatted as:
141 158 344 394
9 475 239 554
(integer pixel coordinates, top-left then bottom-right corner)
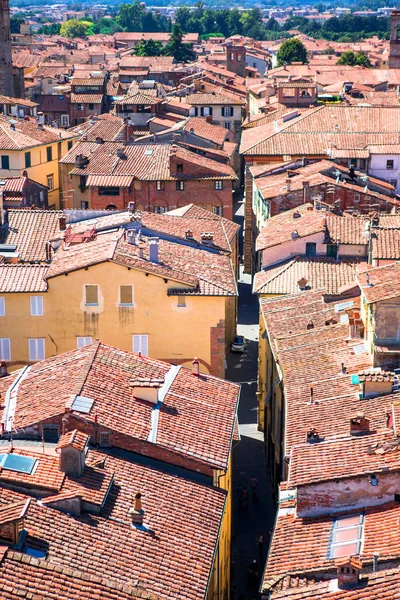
226 197 275 600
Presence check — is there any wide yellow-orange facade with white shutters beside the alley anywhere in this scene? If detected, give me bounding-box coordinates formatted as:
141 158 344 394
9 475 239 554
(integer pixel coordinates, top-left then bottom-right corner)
0 260 236 376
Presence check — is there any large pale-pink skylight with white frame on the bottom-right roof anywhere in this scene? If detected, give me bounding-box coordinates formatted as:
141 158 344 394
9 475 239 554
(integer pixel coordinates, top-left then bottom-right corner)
330 515 363 558
